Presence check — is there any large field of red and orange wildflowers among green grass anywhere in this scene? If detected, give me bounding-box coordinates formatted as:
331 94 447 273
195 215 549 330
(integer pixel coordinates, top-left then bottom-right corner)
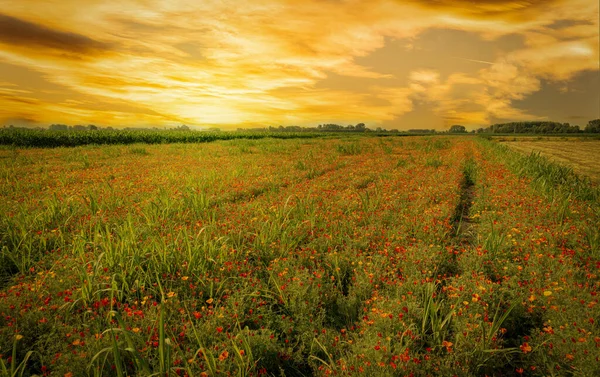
0 136 600 376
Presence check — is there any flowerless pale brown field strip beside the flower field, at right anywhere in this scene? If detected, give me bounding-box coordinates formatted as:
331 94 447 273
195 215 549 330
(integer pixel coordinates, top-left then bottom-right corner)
496 138 600 183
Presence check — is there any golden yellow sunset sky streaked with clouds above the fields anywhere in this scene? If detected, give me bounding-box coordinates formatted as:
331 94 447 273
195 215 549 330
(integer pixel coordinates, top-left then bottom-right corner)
0 0 600 130
